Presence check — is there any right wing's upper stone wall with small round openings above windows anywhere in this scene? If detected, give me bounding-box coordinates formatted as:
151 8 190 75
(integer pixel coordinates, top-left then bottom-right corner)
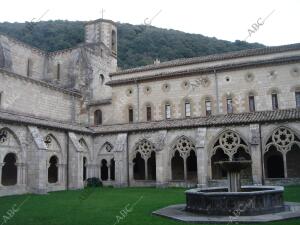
111 64 300 123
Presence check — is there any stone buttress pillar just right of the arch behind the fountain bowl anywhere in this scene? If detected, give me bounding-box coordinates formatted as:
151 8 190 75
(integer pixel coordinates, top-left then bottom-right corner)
249 124 263 185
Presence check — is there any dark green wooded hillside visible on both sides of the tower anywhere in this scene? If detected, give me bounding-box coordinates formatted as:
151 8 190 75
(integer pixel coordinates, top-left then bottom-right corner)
0 20 263 69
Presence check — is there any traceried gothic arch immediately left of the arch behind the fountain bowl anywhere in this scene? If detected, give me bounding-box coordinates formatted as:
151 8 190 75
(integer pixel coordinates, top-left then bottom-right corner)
170 135 197 181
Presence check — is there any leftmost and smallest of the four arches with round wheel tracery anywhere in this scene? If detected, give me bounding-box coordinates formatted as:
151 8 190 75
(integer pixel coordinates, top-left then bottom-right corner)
131 139 156 180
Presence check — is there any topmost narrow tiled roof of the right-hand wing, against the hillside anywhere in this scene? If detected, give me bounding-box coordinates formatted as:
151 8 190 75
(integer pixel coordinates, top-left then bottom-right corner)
110 43 300 76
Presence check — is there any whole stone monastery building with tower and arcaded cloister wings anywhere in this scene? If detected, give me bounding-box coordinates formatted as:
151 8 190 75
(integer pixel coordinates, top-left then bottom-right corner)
0 19 300 196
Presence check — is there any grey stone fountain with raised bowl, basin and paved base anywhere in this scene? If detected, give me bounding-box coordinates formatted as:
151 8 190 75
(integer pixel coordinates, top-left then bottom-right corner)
153 160 300 224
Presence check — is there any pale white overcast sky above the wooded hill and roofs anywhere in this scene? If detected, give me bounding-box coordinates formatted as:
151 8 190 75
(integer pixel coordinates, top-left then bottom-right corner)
0 0 300 45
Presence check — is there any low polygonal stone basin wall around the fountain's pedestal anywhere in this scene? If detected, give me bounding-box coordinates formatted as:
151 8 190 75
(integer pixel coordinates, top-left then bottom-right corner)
185 186 284 216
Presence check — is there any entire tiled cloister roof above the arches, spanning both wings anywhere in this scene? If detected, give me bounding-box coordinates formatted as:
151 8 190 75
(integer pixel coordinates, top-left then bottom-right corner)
0 109 300 134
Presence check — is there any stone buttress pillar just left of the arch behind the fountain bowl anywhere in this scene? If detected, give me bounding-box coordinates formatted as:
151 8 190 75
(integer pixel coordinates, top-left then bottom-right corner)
196 128 209 187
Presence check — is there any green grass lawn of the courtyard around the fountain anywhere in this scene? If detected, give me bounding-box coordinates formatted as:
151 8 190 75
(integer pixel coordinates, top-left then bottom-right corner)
0 186 300 225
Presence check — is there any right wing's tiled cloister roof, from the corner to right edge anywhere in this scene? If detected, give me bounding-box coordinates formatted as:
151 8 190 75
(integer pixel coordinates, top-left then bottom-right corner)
92 109 300 134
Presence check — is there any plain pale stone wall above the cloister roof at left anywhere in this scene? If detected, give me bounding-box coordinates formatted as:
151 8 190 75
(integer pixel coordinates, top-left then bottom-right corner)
0 71 80 122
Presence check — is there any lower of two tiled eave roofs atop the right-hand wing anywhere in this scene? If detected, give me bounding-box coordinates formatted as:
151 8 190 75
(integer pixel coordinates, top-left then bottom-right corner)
106 55 300 86
